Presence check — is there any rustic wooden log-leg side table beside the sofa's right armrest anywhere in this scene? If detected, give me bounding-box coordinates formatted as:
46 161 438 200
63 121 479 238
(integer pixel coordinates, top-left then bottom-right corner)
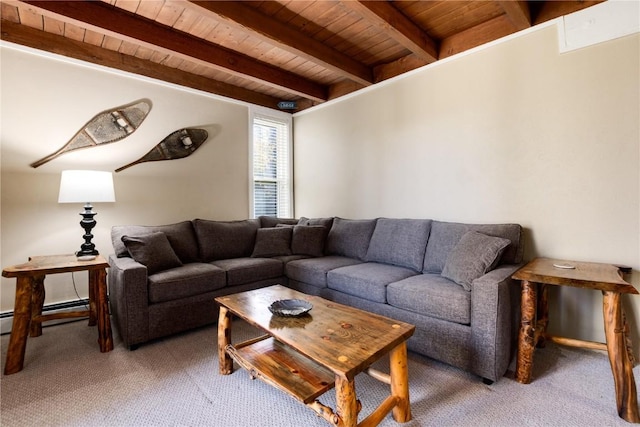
512 258 640 423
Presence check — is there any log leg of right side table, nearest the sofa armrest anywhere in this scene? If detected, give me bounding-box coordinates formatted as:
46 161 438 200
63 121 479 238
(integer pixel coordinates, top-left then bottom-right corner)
516 280 538 384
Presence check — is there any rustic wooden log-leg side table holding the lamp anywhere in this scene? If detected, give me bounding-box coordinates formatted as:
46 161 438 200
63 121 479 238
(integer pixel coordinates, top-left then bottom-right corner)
2 255 113 375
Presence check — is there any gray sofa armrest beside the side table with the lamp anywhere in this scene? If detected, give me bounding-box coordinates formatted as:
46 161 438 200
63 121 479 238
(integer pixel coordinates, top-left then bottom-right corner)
108 254 149 347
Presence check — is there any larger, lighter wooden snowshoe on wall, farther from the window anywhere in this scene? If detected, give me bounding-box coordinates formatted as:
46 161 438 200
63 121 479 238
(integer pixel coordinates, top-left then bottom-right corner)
31 99 151 168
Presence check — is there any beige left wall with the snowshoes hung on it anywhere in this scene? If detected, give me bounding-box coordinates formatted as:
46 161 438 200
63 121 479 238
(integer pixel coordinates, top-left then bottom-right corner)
0 44 255 311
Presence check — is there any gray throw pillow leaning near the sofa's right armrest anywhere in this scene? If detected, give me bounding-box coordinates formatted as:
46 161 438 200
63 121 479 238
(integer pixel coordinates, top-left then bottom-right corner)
442 231 511 291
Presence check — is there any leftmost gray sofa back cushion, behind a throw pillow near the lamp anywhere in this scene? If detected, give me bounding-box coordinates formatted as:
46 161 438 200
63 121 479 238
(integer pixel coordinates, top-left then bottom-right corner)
111 221 198 264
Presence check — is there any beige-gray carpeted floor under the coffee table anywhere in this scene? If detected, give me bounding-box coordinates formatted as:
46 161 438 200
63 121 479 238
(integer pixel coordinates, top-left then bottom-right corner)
0 321 640 427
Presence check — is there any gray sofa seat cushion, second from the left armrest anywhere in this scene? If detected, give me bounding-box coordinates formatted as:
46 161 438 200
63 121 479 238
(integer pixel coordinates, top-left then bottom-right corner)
211 258 284 286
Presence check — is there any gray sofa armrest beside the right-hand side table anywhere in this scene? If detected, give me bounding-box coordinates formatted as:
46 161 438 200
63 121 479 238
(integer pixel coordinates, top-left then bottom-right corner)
471 264 522 381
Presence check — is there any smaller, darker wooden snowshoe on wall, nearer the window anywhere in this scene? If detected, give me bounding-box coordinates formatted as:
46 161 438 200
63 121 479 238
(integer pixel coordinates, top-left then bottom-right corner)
116 128 209 172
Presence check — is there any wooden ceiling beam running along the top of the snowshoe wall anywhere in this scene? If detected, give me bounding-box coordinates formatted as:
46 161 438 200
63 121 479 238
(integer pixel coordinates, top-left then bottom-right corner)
1 19 280 108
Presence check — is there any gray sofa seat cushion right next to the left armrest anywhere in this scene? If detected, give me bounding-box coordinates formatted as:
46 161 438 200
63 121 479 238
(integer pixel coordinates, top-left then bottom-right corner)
148 262 227 304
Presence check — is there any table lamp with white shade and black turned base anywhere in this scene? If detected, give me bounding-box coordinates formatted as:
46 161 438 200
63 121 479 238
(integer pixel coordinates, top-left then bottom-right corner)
58 170 116 260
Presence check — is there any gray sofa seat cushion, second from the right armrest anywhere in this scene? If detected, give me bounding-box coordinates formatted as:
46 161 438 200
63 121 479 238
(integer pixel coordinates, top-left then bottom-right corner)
327 262 416 304
